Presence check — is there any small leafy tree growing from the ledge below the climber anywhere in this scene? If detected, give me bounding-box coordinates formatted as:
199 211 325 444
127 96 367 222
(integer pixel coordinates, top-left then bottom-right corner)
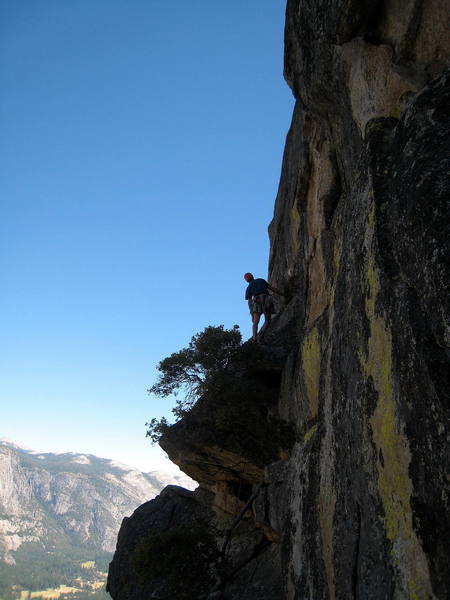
146 325 242 443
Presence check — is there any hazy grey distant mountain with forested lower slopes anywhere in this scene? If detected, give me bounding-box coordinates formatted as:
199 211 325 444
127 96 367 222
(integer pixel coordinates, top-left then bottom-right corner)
0 440 193 600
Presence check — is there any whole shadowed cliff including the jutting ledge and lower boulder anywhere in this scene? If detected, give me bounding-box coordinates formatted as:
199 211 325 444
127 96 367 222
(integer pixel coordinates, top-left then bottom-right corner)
109 0 450 600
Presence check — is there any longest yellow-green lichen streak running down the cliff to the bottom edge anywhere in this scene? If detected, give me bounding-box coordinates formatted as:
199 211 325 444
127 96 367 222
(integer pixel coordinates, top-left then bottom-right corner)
360 258 431 600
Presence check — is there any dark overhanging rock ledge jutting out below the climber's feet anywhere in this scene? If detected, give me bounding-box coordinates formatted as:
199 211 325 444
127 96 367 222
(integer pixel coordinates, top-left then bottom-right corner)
160 343 294 496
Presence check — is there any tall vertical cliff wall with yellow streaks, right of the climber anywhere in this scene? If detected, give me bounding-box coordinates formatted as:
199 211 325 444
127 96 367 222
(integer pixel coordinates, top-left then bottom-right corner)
270 0 450 598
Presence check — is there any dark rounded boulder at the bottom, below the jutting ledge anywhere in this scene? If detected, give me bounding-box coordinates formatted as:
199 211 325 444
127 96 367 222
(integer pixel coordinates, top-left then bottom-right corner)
108 486 217 600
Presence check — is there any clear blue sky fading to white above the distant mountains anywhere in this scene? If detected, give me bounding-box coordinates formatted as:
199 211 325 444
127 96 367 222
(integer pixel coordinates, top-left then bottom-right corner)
0 0 293 470
